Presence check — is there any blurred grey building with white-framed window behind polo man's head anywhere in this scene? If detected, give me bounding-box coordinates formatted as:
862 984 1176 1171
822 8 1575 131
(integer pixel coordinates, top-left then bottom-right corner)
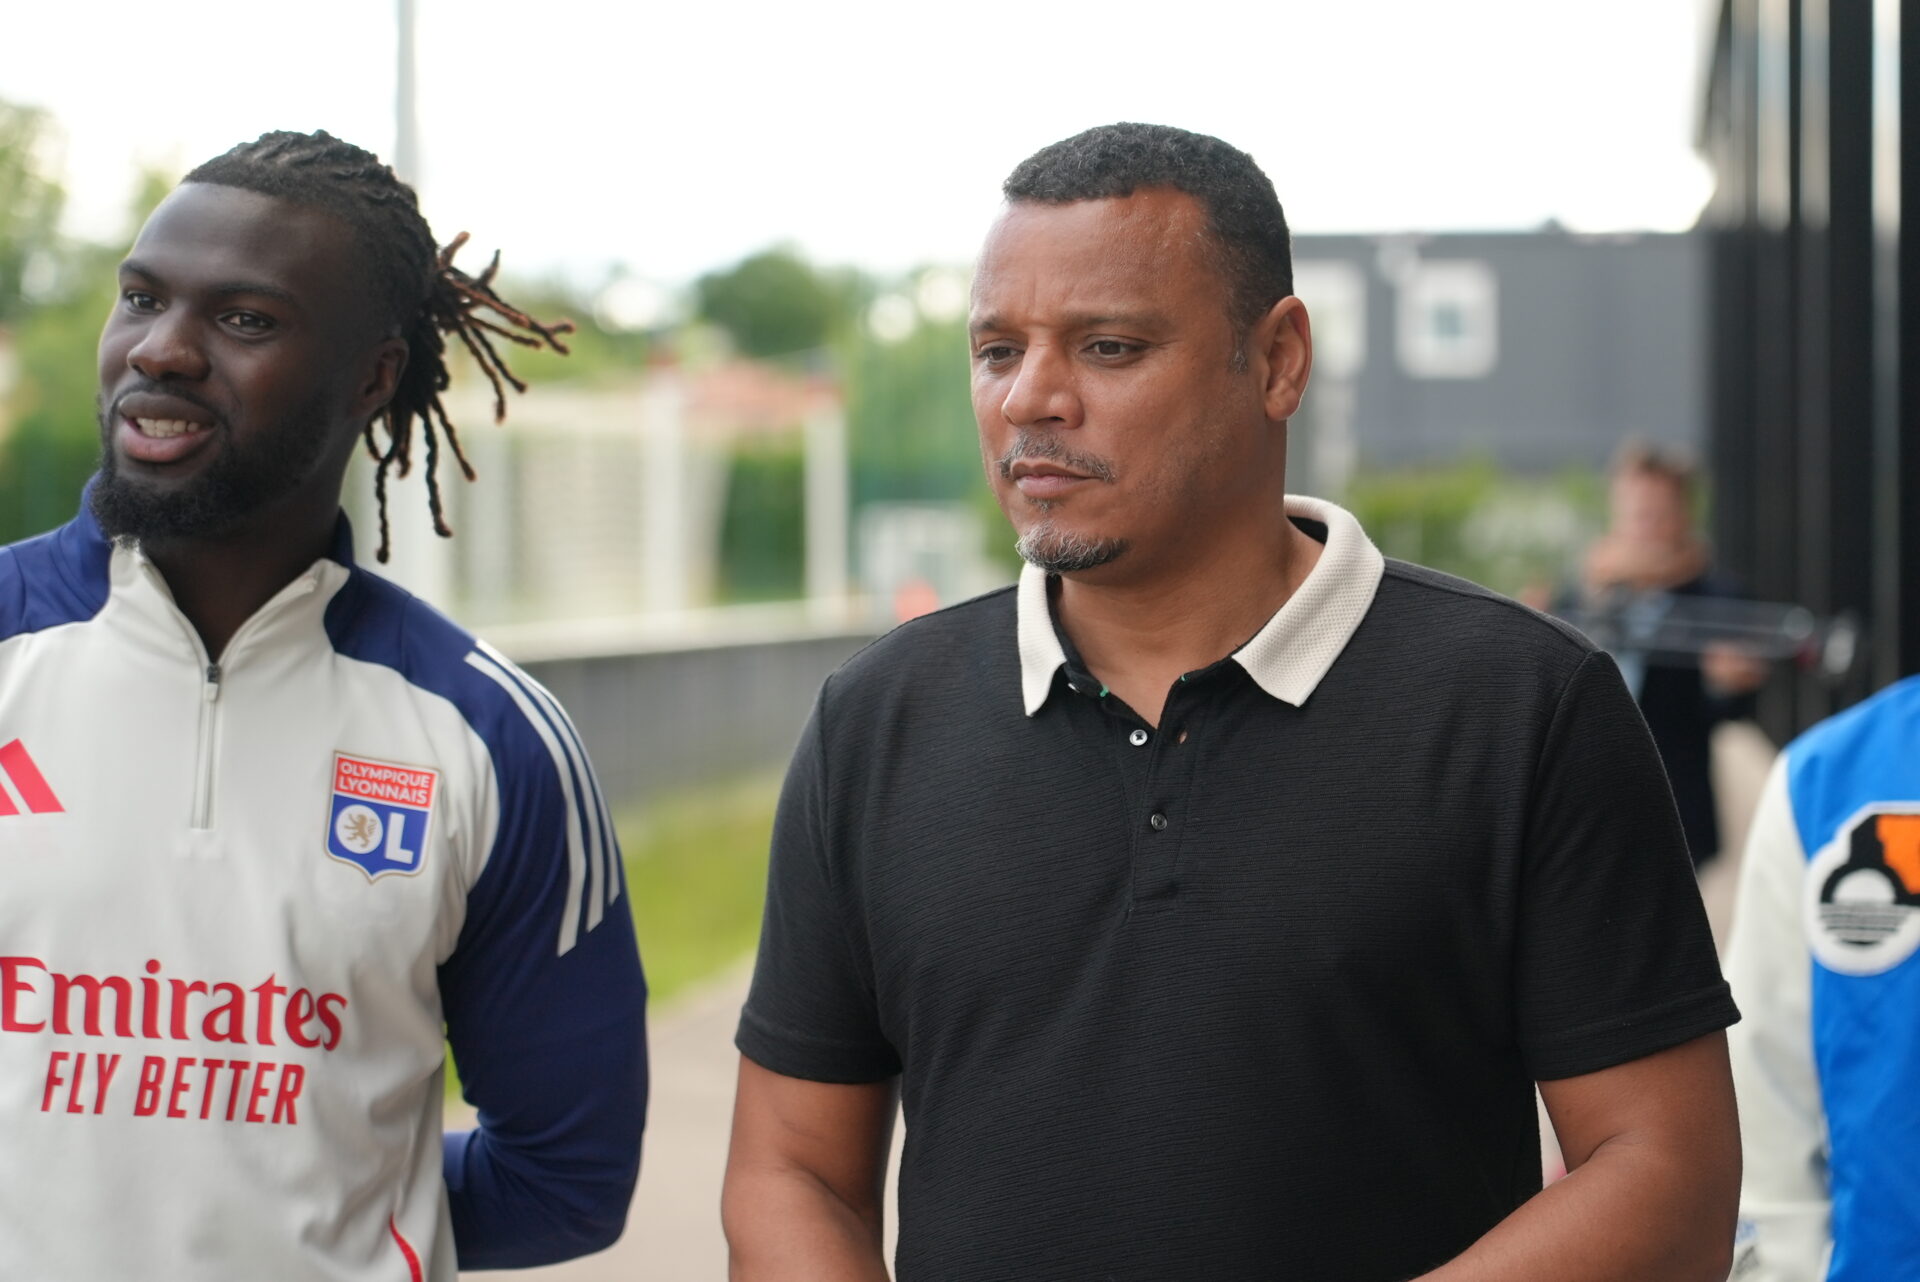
1294 226 1709 493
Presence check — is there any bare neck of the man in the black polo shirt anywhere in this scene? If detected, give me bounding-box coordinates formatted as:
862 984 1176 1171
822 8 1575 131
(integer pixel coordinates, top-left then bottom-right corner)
1060 498 1321 725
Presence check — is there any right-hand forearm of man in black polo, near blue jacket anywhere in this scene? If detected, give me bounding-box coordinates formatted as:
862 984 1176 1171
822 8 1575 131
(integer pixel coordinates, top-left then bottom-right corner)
1417 1140 1738 1282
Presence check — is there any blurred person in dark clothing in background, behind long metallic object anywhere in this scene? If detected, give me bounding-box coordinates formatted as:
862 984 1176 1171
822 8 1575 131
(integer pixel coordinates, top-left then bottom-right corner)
1561 441 1766 867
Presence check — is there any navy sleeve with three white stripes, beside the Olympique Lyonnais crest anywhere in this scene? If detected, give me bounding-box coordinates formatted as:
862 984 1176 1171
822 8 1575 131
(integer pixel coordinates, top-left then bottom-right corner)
440 654 647 1269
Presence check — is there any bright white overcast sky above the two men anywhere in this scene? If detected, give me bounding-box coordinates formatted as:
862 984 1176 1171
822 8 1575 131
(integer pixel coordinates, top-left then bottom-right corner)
0 0 1711 284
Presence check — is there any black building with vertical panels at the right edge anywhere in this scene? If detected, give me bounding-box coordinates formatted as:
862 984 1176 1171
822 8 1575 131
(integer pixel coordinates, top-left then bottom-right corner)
1701 0 1920 735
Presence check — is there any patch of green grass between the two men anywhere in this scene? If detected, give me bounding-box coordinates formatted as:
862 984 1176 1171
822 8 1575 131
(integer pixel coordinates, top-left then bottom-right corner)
447 775 780 1100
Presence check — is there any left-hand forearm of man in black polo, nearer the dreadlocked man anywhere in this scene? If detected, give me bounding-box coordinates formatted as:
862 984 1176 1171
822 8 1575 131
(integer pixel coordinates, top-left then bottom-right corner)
720 1167 889 1282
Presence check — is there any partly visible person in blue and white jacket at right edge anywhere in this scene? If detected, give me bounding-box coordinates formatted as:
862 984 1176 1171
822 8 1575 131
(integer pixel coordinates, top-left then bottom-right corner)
1728 677 1920 1282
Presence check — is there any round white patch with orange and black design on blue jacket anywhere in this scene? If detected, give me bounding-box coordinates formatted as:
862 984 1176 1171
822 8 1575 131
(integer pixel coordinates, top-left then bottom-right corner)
1801 802 1920 975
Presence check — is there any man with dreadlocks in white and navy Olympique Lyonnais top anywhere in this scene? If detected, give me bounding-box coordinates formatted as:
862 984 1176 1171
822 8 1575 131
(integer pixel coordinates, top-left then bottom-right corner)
0 132 647 1282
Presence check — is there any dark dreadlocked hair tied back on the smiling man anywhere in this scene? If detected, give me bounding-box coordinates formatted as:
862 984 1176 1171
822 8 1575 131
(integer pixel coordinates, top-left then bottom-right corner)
182 131 574 562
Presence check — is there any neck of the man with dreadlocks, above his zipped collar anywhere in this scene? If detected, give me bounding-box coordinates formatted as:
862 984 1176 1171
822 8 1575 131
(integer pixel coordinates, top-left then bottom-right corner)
142 499 340 662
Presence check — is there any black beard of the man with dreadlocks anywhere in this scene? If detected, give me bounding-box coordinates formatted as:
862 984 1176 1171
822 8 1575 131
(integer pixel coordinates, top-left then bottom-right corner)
88 385 330 543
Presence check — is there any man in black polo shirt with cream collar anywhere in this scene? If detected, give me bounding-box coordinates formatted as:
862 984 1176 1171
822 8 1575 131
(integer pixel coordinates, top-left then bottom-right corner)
726 125 1740 1282
